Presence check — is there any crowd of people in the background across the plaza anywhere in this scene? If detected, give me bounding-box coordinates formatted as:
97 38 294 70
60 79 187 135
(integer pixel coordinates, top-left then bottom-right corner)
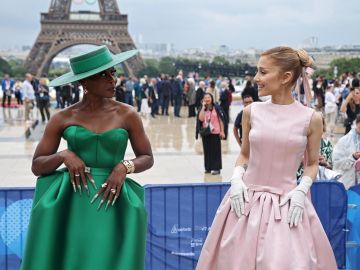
1 67 360 187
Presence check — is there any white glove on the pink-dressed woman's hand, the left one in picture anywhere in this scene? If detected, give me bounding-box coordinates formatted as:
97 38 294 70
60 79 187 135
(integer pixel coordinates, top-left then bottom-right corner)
230 166 249 218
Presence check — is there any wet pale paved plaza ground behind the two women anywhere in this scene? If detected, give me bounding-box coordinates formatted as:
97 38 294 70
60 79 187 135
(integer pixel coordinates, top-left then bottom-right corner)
0 105 242 187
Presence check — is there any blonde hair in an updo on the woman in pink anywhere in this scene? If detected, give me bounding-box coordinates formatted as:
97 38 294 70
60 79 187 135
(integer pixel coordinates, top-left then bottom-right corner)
261 46 314 85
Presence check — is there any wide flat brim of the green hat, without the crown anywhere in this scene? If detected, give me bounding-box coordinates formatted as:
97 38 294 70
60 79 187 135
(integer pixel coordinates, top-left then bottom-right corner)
49 50 138 87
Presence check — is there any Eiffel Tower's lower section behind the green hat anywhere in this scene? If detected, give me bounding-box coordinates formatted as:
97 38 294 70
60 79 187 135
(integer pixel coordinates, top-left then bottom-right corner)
25 0 144 77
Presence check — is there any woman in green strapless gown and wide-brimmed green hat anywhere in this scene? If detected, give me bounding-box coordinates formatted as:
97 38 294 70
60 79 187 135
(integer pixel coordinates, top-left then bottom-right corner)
21 46 153 270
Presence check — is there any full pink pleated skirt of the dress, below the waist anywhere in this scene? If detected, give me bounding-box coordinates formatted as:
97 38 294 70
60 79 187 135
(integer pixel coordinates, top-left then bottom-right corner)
196 187 337 270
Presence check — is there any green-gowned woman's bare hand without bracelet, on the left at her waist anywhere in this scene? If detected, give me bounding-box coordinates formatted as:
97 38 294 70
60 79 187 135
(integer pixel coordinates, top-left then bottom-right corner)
60 149 97 196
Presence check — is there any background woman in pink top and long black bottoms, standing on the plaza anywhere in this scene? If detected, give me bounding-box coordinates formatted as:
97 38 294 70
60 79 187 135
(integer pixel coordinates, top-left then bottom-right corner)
196 93 225 175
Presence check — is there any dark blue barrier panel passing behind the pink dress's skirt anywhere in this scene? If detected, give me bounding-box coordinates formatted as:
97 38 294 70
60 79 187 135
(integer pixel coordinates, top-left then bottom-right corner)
145 181 347 270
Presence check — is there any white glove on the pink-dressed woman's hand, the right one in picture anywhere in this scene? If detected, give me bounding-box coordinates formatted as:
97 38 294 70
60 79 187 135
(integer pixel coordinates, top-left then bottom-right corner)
280 176 313 228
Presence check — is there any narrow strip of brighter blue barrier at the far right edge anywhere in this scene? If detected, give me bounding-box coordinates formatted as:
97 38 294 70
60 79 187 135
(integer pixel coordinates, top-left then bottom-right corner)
346 185 360 270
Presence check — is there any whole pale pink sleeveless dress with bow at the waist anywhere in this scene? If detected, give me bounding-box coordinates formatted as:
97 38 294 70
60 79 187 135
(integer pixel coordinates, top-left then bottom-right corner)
196 101 337 270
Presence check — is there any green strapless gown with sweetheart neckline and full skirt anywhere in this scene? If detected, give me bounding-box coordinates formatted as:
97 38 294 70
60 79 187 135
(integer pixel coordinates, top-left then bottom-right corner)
21 126 147 270
